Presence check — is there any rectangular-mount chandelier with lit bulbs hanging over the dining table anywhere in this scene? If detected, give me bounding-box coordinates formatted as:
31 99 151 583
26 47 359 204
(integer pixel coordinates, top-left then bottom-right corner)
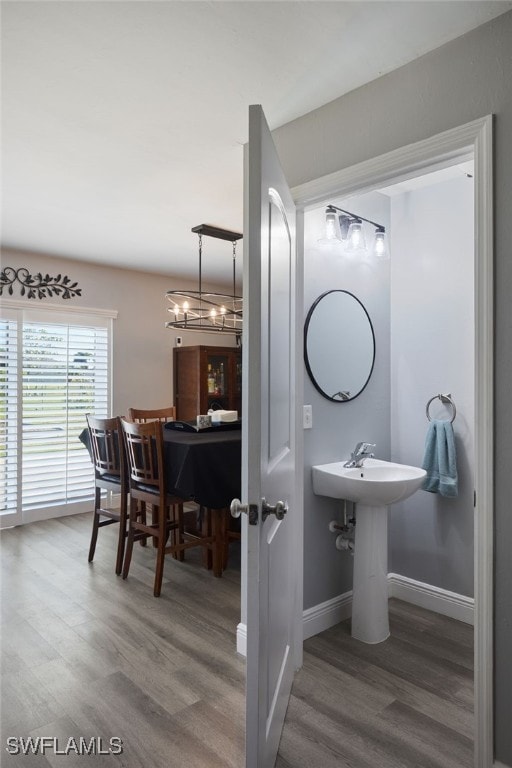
165 224 243 341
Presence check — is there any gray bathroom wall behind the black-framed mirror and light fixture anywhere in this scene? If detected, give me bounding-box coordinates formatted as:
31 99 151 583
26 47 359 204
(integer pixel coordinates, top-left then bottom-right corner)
304 193 390 609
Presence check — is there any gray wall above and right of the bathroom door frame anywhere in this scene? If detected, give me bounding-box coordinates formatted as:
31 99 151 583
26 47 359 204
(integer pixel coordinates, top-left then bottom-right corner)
274 12 512 765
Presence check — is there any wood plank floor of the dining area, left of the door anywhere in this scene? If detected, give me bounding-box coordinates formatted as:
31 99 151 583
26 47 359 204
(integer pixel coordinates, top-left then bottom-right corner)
0 514 245 768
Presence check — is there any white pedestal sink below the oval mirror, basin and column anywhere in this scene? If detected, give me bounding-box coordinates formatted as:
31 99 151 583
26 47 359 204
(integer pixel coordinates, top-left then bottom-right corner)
313 459 426 643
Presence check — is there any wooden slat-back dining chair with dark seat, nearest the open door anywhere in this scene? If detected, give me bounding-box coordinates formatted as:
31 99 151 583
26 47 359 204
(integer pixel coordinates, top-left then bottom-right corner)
121 418 216 597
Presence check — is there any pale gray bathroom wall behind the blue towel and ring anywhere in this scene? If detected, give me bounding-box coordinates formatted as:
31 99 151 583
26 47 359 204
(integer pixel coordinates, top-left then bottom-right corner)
389 176 474 596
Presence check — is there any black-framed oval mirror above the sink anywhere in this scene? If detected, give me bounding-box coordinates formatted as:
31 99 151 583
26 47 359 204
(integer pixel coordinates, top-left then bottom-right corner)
304 290 375 403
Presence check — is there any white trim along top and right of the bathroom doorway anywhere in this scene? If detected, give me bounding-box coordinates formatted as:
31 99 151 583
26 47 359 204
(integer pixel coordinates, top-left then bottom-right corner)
292 115 494 768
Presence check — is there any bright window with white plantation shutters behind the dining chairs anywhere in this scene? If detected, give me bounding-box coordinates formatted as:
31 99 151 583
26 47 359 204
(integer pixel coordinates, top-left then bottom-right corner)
0 302 113 525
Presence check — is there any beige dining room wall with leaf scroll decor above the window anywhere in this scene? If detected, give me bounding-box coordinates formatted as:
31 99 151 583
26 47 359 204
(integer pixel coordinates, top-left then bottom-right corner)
2 249 235 415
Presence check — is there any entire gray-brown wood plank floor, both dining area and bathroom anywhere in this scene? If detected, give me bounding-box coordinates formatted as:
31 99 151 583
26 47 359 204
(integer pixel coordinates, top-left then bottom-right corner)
0 514 473 768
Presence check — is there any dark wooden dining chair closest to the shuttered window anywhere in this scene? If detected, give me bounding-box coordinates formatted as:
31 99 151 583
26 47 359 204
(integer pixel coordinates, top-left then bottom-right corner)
85 413 128 575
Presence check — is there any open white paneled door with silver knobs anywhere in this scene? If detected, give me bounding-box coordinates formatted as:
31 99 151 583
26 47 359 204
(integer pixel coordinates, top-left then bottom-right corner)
242 105 302 768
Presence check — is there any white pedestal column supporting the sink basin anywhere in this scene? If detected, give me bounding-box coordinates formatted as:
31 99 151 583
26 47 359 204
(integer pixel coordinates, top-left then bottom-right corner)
352 504 389 643
